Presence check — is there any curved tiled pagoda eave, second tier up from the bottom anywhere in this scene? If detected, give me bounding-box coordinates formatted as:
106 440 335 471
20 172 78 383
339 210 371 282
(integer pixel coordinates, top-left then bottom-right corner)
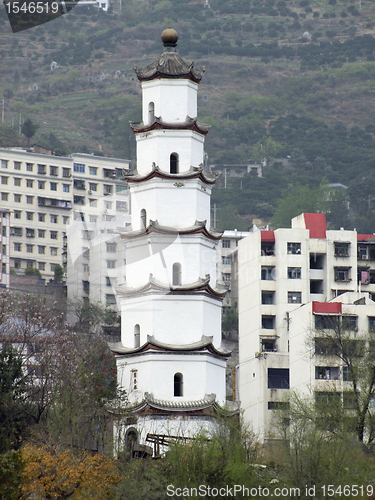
108 335 231 358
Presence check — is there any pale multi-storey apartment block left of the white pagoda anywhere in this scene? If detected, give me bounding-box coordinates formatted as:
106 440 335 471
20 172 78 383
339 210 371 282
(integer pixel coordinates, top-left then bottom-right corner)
0 149 130 300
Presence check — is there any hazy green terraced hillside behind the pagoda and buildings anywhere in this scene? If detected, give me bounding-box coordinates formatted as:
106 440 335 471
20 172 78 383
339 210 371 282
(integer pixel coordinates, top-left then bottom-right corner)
0 0 375 232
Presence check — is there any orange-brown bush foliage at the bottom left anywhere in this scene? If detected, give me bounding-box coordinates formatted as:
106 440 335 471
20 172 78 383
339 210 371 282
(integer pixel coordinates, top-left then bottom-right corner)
22 444 122 500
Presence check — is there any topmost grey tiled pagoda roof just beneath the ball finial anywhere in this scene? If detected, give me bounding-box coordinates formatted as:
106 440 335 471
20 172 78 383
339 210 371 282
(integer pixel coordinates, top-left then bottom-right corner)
134 50 206 83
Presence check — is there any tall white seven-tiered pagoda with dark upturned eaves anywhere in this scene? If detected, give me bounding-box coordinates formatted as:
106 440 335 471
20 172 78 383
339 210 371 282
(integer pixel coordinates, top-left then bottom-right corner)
111 28 229 453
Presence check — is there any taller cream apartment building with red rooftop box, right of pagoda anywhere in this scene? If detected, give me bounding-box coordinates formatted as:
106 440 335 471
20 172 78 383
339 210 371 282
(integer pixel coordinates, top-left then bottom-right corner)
237 214 375 439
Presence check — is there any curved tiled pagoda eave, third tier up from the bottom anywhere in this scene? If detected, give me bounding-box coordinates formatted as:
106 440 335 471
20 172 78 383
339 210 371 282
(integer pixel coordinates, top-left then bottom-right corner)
115 274 227 300
